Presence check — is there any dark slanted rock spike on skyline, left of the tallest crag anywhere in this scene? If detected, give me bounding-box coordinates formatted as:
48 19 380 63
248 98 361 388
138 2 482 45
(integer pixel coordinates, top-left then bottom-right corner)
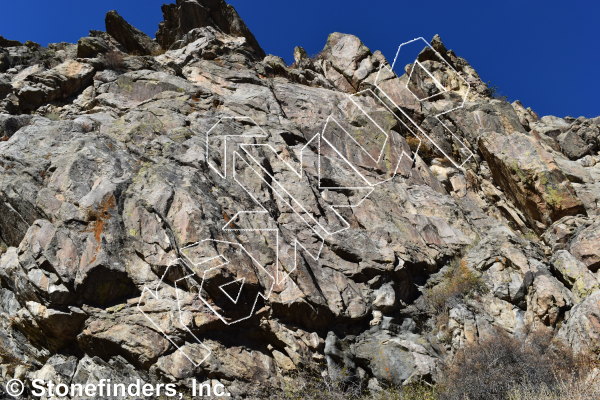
105 10 159 56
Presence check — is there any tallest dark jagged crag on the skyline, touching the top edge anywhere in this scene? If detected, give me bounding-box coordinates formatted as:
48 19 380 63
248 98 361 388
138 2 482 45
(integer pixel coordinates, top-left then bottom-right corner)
156 0 265 59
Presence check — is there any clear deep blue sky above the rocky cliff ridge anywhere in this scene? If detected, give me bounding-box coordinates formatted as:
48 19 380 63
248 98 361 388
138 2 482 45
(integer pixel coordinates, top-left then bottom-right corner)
0 0 600 117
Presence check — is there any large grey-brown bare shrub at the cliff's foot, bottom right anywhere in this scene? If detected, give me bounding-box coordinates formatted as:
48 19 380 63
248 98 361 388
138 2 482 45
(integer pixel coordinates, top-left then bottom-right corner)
440 331 584 400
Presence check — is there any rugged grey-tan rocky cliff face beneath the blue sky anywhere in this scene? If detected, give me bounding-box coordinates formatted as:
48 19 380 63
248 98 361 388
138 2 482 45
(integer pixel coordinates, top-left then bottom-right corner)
0 0 600 398
